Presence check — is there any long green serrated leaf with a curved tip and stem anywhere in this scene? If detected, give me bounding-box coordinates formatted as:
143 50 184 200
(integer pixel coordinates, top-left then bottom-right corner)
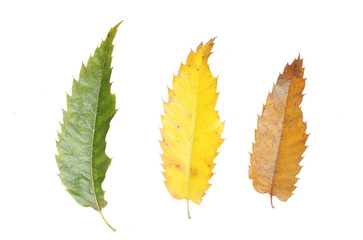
56 23 121 231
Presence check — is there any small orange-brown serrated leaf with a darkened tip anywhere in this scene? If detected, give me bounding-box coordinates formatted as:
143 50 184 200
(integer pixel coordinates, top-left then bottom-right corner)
249 56 308 207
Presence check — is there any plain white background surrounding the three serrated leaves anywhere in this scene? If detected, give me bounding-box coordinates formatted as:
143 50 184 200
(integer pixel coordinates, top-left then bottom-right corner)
0 0 363 240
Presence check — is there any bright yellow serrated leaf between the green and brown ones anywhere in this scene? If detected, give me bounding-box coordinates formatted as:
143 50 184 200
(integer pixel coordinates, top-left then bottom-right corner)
160 39 224 218
